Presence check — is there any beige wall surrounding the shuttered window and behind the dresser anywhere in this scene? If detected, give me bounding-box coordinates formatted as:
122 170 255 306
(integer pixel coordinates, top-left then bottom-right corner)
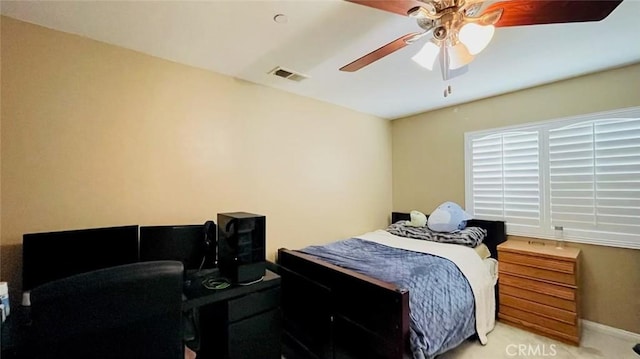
392 64 640 333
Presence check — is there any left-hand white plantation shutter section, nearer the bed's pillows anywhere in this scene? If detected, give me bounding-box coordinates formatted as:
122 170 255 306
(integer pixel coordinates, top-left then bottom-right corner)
467 131 540 233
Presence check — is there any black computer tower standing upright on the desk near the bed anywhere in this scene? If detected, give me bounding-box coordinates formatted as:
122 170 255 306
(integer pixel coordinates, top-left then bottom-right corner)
217 212 266 283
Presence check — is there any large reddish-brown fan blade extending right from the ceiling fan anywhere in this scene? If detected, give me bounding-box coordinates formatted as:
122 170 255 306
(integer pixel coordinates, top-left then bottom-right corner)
483 0 622 27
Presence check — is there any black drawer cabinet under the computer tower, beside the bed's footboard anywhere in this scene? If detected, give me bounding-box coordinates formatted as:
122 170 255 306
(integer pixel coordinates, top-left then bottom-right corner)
189 271 282 359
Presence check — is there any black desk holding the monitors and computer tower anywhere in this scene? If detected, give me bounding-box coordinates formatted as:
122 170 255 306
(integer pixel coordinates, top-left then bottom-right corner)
0 270 282 359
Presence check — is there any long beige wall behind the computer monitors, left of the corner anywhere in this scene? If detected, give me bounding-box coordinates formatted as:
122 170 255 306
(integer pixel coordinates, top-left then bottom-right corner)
1 18 392 304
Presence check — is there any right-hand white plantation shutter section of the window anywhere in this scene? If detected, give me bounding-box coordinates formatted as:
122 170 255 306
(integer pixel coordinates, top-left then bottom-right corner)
549 118 640 243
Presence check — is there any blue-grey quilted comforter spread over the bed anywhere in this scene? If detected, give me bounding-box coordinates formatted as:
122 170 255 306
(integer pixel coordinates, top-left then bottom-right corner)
300 238 475 359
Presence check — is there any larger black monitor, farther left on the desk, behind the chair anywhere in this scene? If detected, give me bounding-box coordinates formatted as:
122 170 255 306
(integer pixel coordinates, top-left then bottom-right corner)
22 225 138 291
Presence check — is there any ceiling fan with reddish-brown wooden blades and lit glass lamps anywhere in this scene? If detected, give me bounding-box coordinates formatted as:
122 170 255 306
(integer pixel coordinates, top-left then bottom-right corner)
340 0 622 80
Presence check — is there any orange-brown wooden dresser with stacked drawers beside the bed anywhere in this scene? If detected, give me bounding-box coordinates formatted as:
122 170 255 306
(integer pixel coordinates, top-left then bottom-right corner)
498 239 580 345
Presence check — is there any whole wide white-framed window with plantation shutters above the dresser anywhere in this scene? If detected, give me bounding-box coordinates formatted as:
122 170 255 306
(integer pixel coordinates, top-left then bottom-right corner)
465 107 640 249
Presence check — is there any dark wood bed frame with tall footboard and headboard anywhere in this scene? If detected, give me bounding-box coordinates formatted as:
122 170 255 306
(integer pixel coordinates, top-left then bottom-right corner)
273 212 506 359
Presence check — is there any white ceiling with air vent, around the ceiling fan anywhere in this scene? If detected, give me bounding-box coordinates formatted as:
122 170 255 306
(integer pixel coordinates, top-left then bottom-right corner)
1 0 640 119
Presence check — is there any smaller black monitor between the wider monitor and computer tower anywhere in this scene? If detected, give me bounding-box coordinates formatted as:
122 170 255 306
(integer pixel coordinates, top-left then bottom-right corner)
140 221 216 273
